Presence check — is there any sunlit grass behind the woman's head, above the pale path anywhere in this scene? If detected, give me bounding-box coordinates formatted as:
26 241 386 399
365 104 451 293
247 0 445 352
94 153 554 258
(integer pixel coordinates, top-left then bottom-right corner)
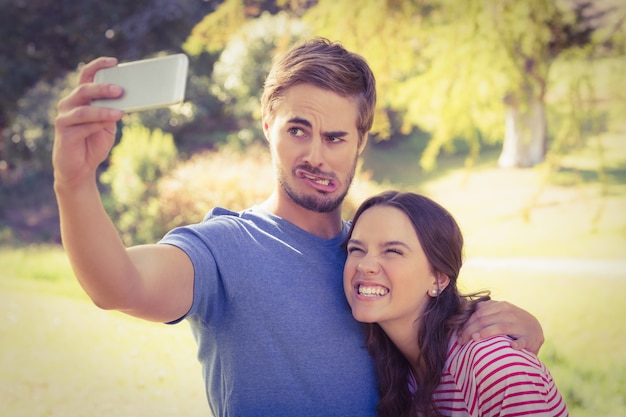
363 133 626 259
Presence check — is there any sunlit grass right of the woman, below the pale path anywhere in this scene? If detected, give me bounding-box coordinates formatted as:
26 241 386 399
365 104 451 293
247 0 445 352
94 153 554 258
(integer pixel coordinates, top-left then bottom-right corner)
460 261 626 417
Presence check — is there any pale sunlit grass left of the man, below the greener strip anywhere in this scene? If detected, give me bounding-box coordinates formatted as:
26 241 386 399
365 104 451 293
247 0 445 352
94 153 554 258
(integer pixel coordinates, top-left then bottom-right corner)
0 278 210 417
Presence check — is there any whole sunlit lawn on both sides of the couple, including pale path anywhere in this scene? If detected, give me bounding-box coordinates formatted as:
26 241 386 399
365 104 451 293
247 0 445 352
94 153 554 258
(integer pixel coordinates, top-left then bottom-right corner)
0 128 626 417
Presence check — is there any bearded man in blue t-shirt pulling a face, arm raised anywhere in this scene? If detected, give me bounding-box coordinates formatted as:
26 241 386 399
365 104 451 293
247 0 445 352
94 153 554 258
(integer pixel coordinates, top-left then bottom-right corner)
53 39 543 416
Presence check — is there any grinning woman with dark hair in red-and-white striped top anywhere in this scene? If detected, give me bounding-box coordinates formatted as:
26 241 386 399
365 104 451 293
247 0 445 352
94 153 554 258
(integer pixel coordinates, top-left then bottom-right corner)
344 191 568 417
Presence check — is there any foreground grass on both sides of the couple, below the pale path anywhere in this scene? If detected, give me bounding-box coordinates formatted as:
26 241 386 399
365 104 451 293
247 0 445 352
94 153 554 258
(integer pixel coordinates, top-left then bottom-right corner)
0 247 626 417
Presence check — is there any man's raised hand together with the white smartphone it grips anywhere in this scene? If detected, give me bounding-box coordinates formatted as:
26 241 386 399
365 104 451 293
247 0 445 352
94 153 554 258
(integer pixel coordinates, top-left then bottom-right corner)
52 54 188 192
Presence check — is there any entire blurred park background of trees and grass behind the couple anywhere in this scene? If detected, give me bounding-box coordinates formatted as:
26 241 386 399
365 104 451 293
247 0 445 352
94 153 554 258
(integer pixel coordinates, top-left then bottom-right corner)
0 0 626 417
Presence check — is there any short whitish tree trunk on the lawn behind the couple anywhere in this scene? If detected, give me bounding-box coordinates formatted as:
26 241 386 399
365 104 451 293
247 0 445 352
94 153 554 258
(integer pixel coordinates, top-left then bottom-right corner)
498 100 546 168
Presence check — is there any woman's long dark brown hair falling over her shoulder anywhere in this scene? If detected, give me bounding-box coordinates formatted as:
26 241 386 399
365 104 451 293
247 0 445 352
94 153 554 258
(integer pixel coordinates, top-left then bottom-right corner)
346 191 489 417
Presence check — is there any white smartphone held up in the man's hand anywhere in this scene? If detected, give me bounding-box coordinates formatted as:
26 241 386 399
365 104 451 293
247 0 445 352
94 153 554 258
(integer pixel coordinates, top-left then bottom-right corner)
91 54 189 113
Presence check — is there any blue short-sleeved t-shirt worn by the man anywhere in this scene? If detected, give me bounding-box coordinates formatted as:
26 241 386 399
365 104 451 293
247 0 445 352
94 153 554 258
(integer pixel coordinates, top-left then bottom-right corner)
160 208 378 417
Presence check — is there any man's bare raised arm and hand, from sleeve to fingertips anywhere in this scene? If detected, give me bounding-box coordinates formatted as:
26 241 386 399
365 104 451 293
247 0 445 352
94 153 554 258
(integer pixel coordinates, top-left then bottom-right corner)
52 58 193 321
